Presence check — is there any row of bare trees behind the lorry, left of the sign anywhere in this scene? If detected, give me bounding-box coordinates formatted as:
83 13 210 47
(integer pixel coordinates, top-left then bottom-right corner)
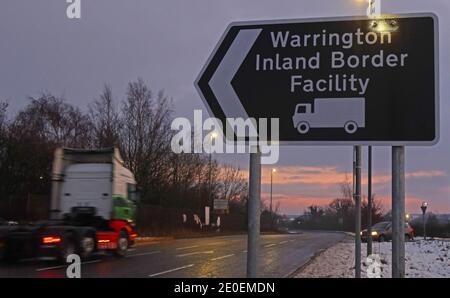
0 79 247 220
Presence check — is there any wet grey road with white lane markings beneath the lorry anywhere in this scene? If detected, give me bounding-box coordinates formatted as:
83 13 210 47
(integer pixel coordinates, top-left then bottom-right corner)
0 232 345 278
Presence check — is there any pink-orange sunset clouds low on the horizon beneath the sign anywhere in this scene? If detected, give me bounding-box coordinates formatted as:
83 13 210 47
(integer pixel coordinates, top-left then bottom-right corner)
244 166 450 214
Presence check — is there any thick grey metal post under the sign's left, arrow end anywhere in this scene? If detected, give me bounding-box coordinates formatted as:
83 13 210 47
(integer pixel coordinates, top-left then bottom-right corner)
247 147 261 278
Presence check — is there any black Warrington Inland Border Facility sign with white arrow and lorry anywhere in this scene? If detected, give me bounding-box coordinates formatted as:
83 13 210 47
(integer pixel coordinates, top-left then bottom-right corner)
196 14 439 145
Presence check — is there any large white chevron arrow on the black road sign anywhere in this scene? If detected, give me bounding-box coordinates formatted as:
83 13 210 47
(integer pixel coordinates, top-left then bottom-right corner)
209 29 262 119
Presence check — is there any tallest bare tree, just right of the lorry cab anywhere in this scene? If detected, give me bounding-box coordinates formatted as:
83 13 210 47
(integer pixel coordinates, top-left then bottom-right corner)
120 79 172 205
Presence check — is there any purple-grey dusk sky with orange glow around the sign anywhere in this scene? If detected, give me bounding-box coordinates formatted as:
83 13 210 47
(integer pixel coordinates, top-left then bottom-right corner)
0 0 450 214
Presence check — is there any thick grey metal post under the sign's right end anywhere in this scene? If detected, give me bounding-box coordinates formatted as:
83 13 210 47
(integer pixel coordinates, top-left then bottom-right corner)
392 146 405 278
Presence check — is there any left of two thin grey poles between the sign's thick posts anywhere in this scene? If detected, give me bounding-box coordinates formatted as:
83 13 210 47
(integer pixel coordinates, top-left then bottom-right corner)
354 146 361 278
